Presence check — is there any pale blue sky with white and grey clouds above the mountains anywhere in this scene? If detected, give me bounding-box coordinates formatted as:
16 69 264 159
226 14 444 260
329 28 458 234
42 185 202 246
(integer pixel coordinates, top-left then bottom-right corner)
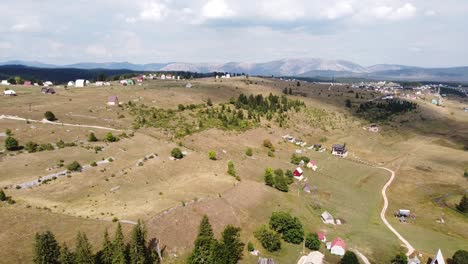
0 0 468 67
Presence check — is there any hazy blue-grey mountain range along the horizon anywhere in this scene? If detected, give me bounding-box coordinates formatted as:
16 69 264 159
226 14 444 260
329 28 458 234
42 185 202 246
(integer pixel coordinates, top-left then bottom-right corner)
0 58 468 82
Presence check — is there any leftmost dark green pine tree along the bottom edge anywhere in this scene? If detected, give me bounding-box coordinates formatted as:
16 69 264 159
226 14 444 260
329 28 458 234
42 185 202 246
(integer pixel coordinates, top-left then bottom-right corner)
33 231 60 264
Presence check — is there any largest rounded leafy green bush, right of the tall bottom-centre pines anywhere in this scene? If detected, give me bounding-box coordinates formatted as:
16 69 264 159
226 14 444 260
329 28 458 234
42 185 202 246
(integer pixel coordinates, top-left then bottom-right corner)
270 212 304 244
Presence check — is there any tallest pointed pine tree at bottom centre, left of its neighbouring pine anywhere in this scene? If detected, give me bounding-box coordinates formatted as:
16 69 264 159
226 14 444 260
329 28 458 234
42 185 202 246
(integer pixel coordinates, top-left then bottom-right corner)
187 215 215 264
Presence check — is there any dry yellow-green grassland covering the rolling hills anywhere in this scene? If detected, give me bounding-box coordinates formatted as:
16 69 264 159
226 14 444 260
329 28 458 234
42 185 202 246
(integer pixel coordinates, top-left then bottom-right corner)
0 78 468 263
